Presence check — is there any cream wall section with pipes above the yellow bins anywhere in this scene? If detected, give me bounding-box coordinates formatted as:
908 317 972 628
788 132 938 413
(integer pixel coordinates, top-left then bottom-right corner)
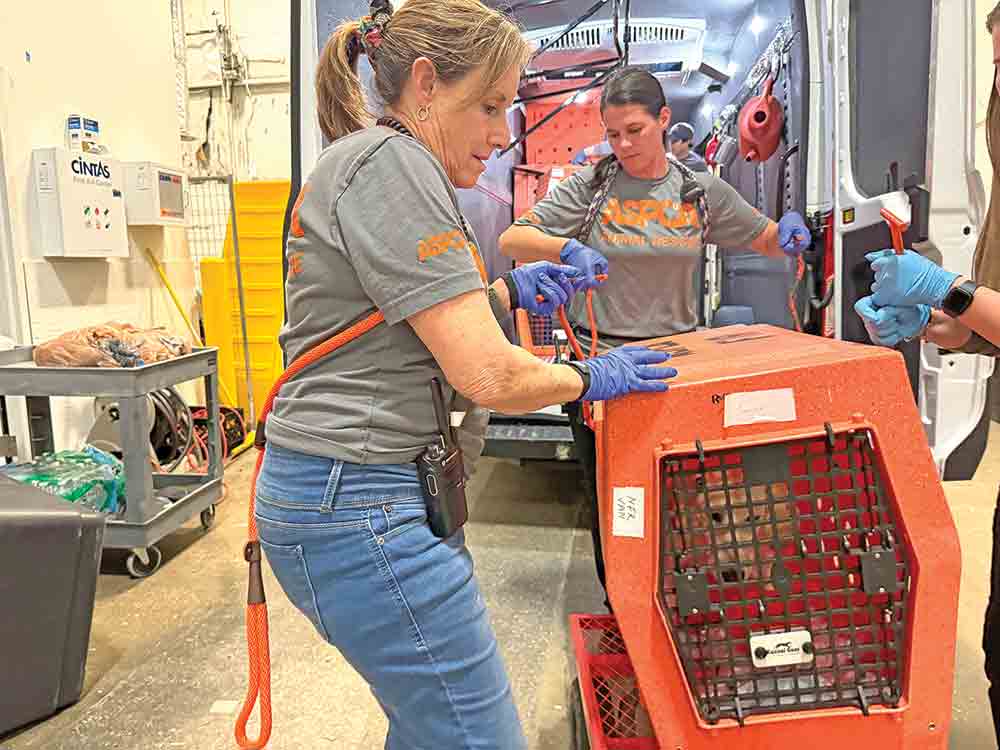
183 0 291 180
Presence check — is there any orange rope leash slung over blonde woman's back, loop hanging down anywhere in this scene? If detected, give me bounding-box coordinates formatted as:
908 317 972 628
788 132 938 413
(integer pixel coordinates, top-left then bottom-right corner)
236 312 384 750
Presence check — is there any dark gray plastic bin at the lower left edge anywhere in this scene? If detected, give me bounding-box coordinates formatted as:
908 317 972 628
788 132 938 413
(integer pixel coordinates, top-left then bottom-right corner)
0 476 105 735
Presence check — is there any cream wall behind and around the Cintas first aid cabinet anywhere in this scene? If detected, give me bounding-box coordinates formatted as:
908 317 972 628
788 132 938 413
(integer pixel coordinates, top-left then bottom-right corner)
0 0 197 456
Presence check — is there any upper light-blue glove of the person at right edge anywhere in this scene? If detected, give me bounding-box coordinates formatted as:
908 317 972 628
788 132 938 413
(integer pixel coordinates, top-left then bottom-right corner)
865 250 958 308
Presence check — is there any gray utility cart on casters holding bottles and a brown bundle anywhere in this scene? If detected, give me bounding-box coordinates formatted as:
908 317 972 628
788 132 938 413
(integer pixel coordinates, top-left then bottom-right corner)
0 347 222 578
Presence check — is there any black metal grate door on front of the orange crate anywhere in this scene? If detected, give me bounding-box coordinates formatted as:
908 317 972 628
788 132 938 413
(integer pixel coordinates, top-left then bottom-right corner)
659 425 910 723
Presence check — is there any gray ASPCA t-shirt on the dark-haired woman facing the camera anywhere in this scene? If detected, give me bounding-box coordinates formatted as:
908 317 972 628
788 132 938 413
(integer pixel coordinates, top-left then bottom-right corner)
515 165 767 338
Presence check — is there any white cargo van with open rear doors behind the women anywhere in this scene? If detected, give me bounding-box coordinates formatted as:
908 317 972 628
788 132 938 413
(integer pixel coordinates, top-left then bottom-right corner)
292 0 993 479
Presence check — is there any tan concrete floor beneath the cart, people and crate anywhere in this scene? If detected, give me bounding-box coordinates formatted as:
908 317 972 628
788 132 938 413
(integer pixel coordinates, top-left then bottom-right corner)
0 424 1000 750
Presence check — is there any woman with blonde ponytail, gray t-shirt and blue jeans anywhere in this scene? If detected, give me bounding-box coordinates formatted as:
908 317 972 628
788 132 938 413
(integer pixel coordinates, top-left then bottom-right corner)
254 0 676 750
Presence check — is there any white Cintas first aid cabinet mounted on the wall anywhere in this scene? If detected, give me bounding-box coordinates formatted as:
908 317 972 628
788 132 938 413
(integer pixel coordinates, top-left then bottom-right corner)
31 148 129 258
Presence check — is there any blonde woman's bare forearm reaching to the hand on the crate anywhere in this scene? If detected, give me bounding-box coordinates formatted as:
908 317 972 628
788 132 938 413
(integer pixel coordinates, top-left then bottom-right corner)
461 344 583 414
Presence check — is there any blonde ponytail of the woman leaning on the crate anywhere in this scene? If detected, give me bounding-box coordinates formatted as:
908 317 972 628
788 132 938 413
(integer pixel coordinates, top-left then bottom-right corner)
316 21 373 141
